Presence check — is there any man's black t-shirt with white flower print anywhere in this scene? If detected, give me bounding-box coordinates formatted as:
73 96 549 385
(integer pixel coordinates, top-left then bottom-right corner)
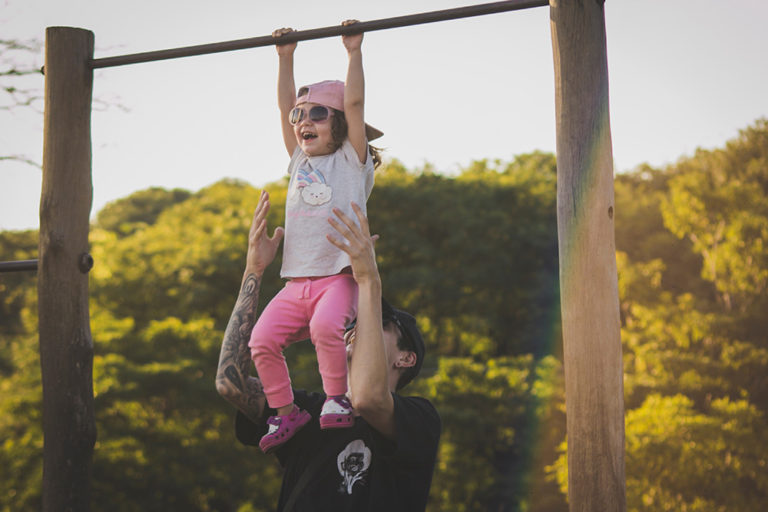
235 391 441 512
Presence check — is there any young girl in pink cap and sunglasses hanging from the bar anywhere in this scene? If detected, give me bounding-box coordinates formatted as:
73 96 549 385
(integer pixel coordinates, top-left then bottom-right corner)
248 21 383 452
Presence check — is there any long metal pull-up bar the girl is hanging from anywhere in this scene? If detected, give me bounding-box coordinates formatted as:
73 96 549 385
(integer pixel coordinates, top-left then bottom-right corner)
91 0 549 69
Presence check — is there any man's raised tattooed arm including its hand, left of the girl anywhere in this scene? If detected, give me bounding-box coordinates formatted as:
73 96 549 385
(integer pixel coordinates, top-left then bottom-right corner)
216 191 283 421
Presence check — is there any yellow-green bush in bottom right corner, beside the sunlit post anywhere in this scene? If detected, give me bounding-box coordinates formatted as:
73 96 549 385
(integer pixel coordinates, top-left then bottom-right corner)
626 395 768 512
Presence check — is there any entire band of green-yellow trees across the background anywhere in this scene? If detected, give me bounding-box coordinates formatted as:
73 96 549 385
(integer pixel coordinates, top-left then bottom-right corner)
0 120 768 512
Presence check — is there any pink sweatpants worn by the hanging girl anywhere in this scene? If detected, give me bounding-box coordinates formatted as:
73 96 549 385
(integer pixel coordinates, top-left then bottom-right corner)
248 273 357 408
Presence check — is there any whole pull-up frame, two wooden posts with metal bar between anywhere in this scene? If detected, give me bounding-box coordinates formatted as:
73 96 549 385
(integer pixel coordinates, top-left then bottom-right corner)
37 0 626 512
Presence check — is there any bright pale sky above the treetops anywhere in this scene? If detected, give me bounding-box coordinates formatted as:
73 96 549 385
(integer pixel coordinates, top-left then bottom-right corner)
0 0 768 230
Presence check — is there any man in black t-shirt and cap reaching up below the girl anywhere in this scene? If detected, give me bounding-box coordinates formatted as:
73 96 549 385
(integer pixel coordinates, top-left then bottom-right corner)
216 192 440 512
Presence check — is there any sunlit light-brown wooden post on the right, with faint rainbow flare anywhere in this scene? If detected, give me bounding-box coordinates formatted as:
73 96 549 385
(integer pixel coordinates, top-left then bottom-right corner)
550 0 626 512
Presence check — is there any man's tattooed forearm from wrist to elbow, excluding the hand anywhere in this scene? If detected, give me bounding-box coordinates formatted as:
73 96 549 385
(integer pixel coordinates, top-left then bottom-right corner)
216 271 264 419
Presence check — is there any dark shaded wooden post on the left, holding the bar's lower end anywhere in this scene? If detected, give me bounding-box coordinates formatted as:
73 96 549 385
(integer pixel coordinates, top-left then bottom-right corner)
37 27 96 512
